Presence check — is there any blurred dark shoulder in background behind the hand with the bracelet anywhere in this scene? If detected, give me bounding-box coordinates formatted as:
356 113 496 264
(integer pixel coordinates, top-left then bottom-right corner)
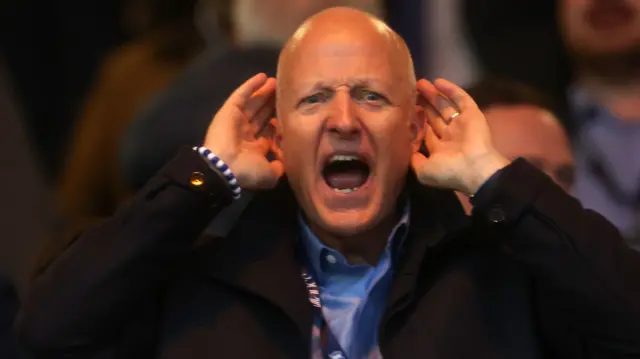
120 47 279 188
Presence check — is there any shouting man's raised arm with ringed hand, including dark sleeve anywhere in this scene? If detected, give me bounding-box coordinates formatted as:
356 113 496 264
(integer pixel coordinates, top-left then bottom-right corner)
413 80 640 358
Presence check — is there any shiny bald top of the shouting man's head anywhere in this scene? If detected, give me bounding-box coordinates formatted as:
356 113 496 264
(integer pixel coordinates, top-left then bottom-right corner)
277 7 416 102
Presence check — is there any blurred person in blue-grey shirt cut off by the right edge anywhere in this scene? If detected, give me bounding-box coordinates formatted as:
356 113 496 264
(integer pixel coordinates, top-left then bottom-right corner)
559 0 640 249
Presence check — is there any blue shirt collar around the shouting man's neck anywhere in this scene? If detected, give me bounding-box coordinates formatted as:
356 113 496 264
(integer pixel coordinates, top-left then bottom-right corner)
298 199 411 284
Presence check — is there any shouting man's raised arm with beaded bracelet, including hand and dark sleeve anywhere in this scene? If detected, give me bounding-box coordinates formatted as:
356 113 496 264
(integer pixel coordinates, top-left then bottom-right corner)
17 74 282 358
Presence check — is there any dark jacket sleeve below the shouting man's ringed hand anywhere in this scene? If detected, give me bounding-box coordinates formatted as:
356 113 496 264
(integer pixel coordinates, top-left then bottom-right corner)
474 159 640 358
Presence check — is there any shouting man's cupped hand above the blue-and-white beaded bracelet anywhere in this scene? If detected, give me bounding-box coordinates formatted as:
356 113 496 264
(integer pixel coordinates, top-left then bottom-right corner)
204 74 283 190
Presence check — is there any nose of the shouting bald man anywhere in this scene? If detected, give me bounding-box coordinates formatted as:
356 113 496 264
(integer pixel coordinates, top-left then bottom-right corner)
327 91 362 138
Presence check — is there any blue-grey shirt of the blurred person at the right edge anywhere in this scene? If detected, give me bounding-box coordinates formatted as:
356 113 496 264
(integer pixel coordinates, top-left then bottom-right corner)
570 87 640 250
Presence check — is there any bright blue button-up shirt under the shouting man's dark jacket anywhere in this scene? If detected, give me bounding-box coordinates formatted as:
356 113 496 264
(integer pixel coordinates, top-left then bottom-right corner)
301 204 409 359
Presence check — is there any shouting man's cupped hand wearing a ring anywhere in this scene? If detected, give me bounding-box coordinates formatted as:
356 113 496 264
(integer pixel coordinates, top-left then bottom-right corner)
411 79 509 195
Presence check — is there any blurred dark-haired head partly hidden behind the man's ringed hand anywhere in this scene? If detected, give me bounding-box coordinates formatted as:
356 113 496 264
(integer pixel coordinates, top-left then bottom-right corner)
459 79 574 213
